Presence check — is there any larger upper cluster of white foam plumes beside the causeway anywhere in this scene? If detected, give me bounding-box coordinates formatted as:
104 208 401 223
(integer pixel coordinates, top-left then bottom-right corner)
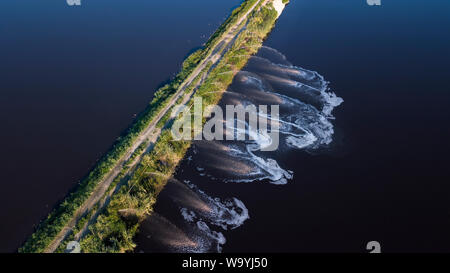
191 46 343 184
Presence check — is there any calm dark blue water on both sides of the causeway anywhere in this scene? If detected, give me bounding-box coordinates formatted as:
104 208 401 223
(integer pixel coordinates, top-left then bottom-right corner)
0 0 450 252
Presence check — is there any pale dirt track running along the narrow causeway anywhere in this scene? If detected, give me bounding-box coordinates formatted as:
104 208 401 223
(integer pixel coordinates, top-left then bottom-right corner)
44 0 269 253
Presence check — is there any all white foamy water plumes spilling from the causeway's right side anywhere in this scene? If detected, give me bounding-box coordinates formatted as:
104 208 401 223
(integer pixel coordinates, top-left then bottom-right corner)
146 46 343 252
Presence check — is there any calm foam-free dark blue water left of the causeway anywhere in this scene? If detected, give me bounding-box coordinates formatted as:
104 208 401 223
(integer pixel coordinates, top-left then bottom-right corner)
0 0 240 251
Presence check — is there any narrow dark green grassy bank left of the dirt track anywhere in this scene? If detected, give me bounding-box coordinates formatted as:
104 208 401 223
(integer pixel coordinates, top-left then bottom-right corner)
18 0 268 252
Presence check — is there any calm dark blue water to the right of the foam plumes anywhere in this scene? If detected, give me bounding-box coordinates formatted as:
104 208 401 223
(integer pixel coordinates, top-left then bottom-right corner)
256 0 450 252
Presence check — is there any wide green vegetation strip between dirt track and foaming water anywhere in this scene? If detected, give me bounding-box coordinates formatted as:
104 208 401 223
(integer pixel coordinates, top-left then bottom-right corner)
80 1 277 252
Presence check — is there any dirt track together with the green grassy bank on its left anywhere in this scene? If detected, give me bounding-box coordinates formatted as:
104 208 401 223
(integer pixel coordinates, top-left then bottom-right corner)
19 0 267 252
